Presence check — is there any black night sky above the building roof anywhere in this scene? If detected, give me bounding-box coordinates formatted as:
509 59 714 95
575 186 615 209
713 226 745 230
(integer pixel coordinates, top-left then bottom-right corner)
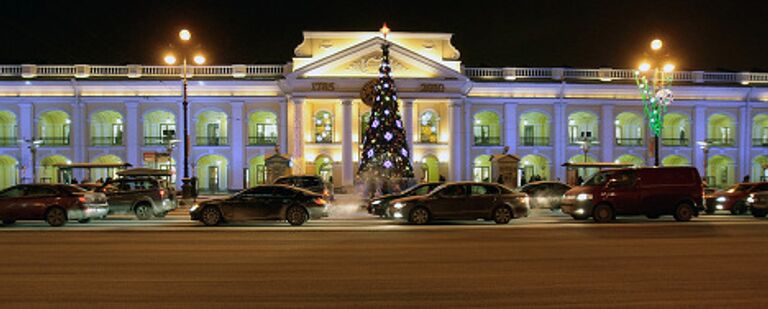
0 0 768 72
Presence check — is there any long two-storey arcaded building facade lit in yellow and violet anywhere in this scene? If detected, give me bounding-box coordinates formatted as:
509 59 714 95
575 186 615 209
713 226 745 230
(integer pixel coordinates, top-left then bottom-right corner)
0 32 768 191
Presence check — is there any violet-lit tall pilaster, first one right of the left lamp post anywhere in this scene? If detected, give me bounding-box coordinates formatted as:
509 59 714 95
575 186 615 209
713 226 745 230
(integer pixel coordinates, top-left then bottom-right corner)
228 102 244 190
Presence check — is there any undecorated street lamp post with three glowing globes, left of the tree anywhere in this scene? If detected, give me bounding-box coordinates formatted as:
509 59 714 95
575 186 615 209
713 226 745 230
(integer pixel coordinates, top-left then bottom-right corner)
164 29 205 198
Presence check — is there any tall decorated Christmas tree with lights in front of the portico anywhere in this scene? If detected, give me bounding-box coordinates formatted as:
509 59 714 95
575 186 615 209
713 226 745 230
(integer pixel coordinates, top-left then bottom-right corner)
358 24 413 179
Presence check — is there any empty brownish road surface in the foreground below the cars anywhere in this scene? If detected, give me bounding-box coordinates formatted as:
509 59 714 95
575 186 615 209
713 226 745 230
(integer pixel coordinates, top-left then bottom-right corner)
0 216 768 308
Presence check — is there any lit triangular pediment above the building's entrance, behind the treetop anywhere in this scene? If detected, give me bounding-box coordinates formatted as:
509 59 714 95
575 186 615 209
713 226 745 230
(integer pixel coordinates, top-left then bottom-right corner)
288 37 467 80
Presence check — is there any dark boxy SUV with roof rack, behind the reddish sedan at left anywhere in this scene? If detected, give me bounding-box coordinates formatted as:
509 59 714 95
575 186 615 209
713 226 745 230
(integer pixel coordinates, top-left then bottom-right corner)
97 178 178 220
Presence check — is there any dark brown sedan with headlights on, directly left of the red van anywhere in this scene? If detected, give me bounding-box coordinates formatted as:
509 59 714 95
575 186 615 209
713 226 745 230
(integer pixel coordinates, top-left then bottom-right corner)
389 182 529 224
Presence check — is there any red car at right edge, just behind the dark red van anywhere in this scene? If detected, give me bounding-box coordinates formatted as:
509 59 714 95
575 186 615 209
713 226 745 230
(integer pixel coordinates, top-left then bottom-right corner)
706 182 768 215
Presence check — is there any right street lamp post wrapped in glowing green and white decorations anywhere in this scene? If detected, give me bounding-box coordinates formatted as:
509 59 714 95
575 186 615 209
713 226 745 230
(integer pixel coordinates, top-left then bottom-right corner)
635 39 675 166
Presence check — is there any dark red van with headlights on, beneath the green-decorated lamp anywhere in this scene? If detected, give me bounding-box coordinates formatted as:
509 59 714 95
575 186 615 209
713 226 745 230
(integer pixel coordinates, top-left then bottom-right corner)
561 167 704 222
